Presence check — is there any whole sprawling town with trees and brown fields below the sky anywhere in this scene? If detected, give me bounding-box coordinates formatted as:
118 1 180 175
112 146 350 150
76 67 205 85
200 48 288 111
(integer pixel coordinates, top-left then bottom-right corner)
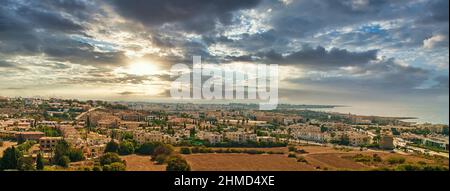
0 97 449 171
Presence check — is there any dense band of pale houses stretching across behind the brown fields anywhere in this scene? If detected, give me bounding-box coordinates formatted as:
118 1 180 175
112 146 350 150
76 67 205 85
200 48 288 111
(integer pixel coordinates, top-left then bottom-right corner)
0 99 448 166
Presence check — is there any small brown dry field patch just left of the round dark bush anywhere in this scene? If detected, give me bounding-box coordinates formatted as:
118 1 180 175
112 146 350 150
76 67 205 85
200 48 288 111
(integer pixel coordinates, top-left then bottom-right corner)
121 155 166 171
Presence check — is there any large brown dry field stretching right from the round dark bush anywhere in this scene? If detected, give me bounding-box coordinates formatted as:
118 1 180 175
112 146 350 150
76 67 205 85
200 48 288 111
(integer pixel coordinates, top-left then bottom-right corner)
178 146 448 171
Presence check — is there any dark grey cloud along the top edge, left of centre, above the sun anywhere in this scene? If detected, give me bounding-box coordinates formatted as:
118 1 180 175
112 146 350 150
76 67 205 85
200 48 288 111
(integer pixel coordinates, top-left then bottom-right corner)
110 0 260 33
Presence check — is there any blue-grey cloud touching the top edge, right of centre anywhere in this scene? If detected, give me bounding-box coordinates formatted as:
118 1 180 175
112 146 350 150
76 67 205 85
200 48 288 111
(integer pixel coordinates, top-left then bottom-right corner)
272 0 392 37
